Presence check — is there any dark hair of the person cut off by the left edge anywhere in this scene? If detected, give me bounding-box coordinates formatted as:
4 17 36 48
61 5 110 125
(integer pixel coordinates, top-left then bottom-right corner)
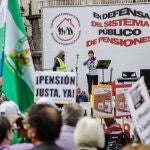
0 116 11 143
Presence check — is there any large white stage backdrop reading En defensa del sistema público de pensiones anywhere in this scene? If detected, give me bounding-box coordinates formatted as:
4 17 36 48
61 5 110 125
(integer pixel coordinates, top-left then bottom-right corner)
42 4 150 91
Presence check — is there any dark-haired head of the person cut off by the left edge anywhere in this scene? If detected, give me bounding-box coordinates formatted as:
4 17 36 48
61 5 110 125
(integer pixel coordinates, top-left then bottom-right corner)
0 116 12 145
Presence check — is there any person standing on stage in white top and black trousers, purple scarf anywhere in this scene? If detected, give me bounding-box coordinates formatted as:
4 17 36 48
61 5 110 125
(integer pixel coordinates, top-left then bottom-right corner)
83 50 98 94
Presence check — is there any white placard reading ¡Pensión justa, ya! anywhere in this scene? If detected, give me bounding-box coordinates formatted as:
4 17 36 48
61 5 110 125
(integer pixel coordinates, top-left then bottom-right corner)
35 71 76 104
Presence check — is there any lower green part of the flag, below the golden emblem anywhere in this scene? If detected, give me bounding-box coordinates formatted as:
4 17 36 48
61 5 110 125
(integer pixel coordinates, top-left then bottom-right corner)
3 58 34 112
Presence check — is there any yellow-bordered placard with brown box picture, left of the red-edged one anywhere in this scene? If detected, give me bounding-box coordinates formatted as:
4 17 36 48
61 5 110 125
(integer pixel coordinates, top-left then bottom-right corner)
92 85 113 117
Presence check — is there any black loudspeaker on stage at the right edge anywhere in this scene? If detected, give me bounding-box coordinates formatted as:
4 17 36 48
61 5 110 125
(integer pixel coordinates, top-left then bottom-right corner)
140 69 150 89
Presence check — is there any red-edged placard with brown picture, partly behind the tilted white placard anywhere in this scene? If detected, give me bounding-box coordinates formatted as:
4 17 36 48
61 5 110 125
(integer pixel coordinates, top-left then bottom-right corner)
115 84 131 117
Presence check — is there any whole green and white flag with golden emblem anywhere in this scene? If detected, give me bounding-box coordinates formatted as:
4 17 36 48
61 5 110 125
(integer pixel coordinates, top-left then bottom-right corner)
0 0 35 112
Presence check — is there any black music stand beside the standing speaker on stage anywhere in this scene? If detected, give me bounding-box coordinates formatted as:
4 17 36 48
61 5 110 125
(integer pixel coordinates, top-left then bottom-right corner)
96 60 111 84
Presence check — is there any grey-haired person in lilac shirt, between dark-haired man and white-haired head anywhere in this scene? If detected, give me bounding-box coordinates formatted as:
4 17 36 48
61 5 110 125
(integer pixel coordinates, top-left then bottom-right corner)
56 103 84 150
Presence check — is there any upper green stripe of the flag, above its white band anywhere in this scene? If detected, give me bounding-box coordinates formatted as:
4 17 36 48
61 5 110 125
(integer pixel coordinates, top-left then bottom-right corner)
8 0 26 35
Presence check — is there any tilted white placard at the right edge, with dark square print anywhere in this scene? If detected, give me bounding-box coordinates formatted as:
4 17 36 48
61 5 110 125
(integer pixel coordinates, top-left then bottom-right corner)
126 77 150 144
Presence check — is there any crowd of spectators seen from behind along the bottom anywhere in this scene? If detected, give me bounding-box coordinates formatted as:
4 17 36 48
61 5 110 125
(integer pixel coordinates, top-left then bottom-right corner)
0 92 150 150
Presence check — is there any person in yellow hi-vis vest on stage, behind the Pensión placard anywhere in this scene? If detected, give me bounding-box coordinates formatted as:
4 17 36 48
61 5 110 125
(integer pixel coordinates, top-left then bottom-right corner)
53 50 67 72
